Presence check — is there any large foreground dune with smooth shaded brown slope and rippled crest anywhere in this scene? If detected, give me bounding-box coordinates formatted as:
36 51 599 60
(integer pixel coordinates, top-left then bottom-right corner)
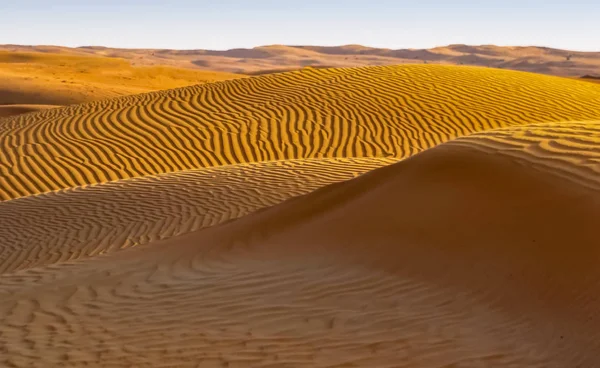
0 122 600 368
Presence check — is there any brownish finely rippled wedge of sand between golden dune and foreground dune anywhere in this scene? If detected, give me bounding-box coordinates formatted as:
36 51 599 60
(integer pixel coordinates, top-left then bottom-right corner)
0 158 396 274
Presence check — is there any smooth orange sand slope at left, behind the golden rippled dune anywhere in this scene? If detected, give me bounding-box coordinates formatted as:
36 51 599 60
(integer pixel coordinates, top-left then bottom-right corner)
0 50 240 117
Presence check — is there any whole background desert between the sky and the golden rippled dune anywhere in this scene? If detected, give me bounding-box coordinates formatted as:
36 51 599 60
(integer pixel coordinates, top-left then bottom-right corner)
0 45 600 117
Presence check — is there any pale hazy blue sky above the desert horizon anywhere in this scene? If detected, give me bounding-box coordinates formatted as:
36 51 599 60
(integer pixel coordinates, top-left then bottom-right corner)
0 0 600 51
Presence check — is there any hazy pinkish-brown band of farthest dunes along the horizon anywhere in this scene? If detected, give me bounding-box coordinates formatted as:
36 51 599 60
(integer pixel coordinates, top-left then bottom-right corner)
0 45 600 77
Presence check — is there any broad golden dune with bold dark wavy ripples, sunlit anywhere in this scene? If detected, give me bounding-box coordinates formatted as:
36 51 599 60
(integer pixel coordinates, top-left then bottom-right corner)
0 65 600 199
